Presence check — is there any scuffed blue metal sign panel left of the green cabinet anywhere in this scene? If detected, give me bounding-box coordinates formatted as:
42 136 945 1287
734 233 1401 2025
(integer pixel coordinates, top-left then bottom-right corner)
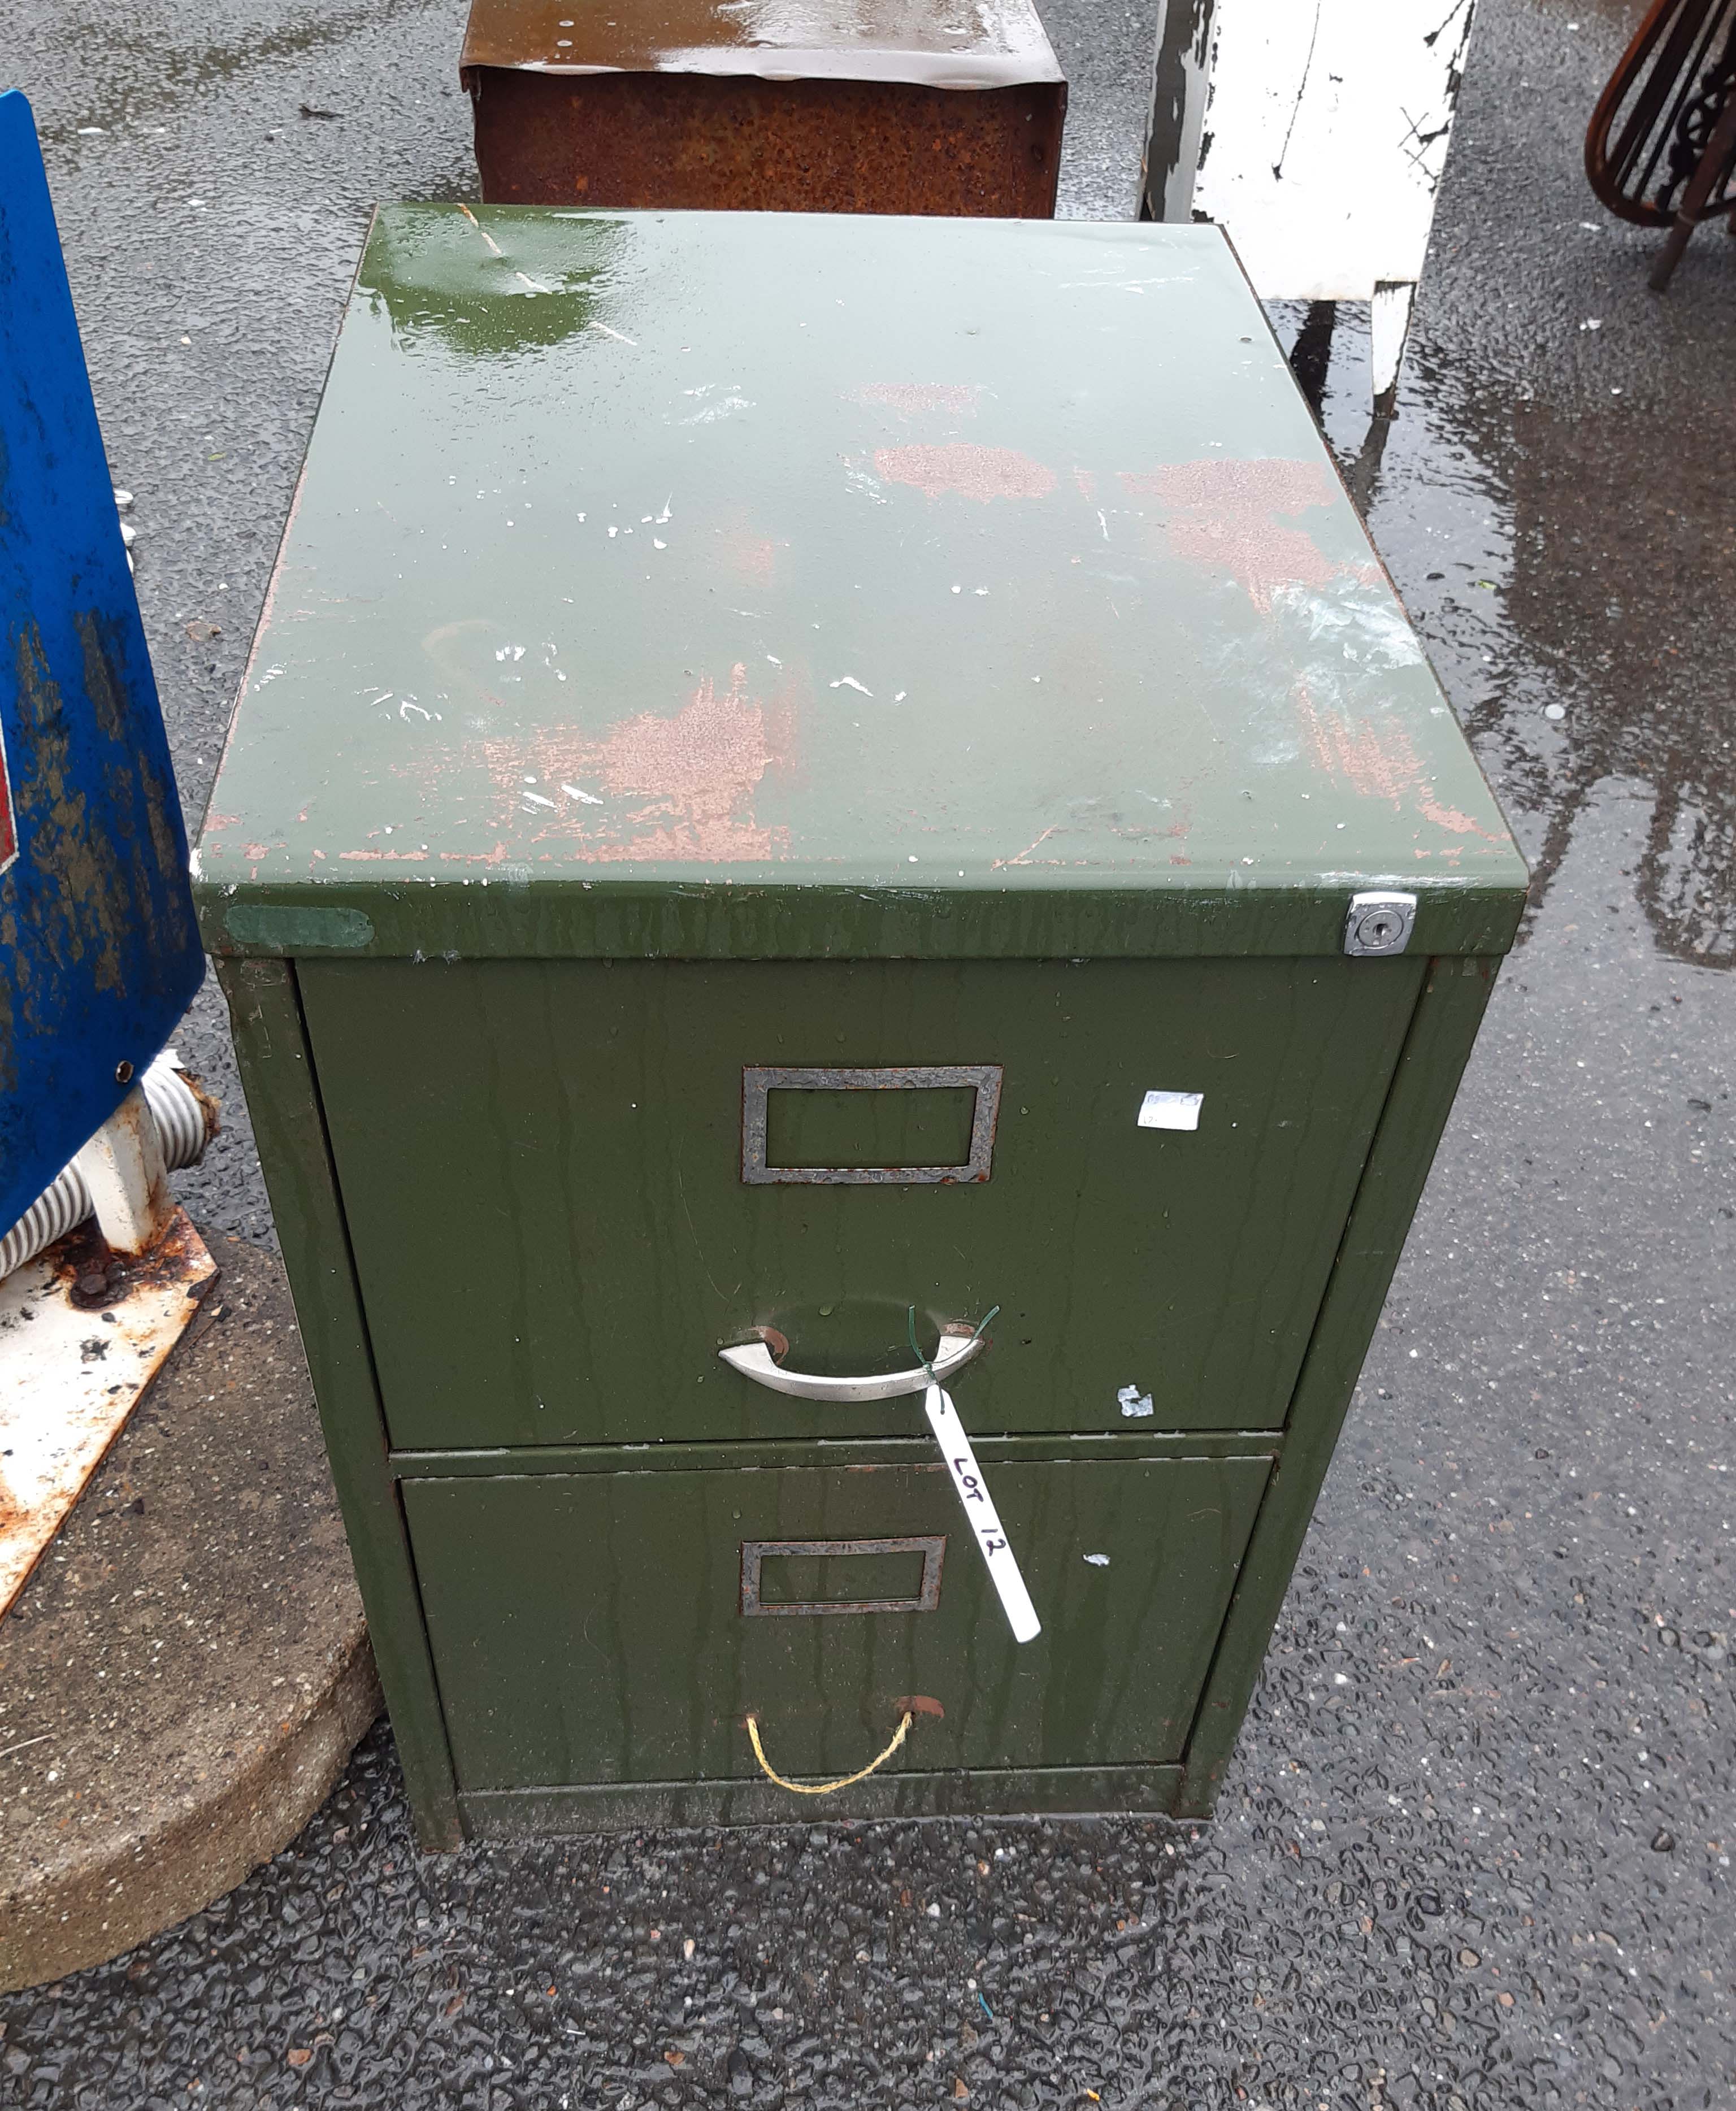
0 93 205 1231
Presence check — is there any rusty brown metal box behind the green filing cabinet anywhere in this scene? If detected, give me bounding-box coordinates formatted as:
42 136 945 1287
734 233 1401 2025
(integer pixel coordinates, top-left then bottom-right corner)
461 0 1066 218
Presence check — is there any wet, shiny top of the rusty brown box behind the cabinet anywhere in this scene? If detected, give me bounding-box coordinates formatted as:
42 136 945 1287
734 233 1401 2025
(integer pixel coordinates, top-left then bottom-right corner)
461 0 1062 89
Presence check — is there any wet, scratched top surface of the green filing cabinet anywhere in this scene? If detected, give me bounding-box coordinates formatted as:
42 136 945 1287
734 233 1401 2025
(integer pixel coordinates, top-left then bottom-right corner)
197 205 1525 950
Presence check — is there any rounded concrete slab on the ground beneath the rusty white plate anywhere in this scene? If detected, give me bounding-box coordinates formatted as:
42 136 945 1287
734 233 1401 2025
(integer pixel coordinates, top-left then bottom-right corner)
0 1239 380 1993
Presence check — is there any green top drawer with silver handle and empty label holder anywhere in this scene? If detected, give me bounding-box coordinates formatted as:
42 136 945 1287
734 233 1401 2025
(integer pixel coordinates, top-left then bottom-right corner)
300 958 1423 1450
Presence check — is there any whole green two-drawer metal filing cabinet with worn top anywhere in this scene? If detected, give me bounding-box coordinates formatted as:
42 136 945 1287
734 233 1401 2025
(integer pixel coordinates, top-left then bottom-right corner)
198 207 1525 1843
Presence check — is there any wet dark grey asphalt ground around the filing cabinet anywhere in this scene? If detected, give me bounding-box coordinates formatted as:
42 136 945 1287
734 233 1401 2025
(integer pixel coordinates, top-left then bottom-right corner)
0 0 1736 2111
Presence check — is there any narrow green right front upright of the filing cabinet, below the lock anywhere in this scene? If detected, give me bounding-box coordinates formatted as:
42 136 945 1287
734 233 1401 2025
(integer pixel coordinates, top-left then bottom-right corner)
1177 958 1499 1815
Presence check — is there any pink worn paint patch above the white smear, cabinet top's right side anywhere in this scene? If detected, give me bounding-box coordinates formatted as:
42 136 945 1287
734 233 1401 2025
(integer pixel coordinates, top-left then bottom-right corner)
1121 456 1337 614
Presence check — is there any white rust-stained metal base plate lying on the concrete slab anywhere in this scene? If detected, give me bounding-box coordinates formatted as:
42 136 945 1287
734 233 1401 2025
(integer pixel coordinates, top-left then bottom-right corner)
0 1210 218 1613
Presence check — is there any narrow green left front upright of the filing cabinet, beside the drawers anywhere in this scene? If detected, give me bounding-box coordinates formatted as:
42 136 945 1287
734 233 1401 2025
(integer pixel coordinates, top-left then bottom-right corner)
218 961 462 1849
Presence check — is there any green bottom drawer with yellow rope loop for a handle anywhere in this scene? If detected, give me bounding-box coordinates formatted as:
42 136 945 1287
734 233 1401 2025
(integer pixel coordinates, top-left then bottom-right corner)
403 1444 1271 1792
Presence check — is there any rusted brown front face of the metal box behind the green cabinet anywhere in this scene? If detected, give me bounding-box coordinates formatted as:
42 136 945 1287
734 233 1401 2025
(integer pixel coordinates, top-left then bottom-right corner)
465 66 1066 220
